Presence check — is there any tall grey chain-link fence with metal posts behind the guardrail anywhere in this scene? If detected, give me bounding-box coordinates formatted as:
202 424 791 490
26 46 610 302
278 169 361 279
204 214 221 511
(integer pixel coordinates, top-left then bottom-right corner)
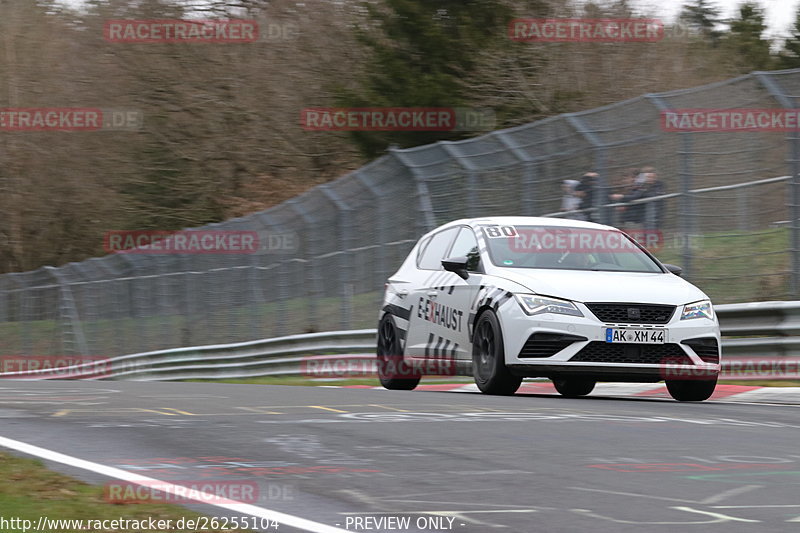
0 70 800 356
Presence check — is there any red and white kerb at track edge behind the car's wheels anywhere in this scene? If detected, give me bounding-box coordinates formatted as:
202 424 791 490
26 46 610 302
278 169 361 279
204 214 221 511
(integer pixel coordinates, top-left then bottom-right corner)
344 381 800 405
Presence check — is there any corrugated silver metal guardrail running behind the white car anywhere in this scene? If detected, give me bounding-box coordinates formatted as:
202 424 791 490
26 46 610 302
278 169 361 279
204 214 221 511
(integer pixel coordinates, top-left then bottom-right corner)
0 301 800 381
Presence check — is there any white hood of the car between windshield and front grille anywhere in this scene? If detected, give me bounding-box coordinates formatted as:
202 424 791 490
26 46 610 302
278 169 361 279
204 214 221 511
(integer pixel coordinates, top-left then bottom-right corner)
492 268 707 305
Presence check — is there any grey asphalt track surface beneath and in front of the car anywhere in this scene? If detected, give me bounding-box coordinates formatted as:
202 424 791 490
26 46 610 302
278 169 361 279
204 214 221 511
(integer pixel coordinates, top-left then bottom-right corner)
0 381 800 533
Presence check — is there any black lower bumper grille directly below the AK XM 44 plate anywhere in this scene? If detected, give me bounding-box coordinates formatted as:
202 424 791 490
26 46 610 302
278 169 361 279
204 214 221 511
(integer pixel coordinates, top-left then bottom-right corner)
570 341 692 365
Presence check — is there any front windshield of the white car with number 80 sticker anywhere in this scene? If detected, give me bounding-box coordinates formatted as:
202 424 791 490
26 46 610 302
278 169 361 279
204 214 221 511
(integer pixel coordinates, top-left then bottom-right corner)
481 226 664 272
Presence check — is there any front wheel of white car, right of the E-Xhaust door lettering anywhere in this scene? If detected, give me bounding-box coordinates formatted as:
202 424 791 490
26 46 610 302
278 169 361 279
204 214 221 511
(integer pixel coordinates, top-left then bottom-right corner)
472 311 522 396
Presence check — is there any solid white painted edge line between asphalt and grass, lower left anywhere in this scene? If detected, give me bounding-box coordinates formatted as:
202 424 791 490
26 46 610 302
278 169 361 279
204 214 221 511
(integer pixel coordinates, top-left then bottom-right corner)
0 437 345 533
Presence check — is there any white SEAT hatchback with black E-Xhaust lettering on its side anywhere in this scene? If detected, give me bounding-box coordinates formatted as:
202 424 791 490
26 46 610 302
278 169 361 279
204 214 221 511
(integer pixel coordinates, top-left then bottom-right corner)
377 217 720 401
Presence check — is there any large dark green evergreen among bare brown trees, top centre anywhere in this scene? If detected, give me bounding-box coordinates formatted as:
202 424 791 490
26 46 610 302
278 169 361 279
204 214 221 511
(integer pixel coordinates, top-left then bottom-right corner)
340 0 511 158
